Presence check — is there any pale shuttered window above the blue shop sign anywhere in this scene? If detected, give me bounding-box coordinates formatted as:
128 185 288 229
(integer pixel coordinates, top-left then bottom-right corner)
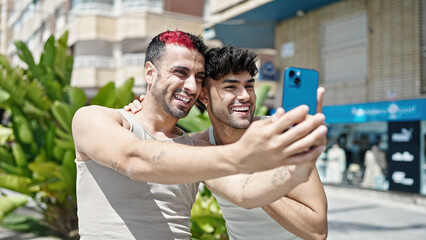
320 12 368 83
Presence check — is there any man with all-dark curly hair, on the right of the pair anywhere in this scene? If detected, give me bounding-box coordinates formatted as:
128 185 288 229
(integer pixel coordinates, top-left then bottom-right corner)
127 47 328 240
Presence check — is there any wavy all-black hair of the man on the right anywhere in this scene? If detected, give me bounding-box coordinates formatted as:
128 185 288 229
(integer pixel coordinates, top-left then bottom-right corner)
205 46 258 85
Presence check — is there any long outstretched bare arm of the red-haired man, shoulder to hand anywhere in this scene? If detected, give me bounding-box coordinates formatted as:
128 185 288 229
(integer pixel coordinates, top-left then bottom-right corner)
72 106 320 184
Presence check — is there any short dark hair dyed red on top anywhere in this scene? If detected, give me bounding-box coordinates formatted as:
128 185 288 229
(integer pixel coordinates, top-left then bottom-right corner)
145 30 207 67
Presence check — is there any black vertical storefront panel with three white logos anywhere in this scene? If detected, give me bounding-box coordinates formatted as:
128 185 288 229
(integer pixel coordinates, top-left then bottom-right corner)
387 121 420 193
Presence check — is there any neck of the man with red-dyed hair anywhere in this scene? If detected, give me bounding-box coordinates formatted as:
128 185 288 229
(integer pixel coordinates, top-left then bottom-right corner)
135 95 182 139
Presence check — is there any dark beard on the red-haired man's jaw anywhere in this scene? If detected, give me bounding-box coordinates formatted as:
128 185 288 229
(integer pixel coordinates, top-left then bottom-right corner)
151 79 191 119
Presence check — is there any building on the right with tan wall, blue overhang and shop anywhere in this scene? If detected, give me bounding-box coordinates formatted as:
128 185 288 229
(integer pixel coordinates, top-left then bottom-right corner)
205 0 426 194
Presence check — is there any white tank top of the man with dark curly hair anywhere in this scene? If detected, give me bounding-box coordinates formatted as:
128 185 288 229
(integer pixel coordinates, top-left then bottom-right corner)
209 127 299 240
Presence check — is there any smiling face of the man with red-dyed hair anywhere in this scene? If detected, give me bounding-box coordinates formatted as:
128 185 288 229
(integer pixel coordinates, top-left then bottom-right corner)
145 44 205 118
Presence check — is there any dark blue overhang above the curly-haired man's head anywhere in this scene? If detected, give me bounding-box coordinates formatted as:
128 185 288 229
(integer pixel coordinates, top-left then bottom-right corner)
206 0 339 48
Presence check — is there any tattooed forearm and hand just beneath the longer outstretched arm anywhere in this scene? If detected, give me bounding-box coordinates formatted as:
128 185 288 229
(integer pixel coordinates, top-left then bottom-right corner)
205 112 327 208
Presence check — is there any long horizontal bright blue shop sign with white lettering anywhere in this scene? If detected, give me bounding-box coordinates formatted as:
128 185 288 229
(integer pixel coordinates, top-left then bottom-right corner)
323 99 426 124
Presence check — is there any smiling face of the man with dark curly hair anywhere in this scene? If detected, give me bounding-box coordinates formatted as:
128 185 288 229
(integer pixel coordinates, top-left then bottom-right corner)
200 72 256 129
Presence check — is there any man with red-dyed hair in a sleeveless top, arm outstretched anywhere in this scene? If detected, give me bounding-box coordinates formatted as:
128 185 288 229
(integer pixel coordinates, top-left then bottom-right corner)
72 31 324 240
